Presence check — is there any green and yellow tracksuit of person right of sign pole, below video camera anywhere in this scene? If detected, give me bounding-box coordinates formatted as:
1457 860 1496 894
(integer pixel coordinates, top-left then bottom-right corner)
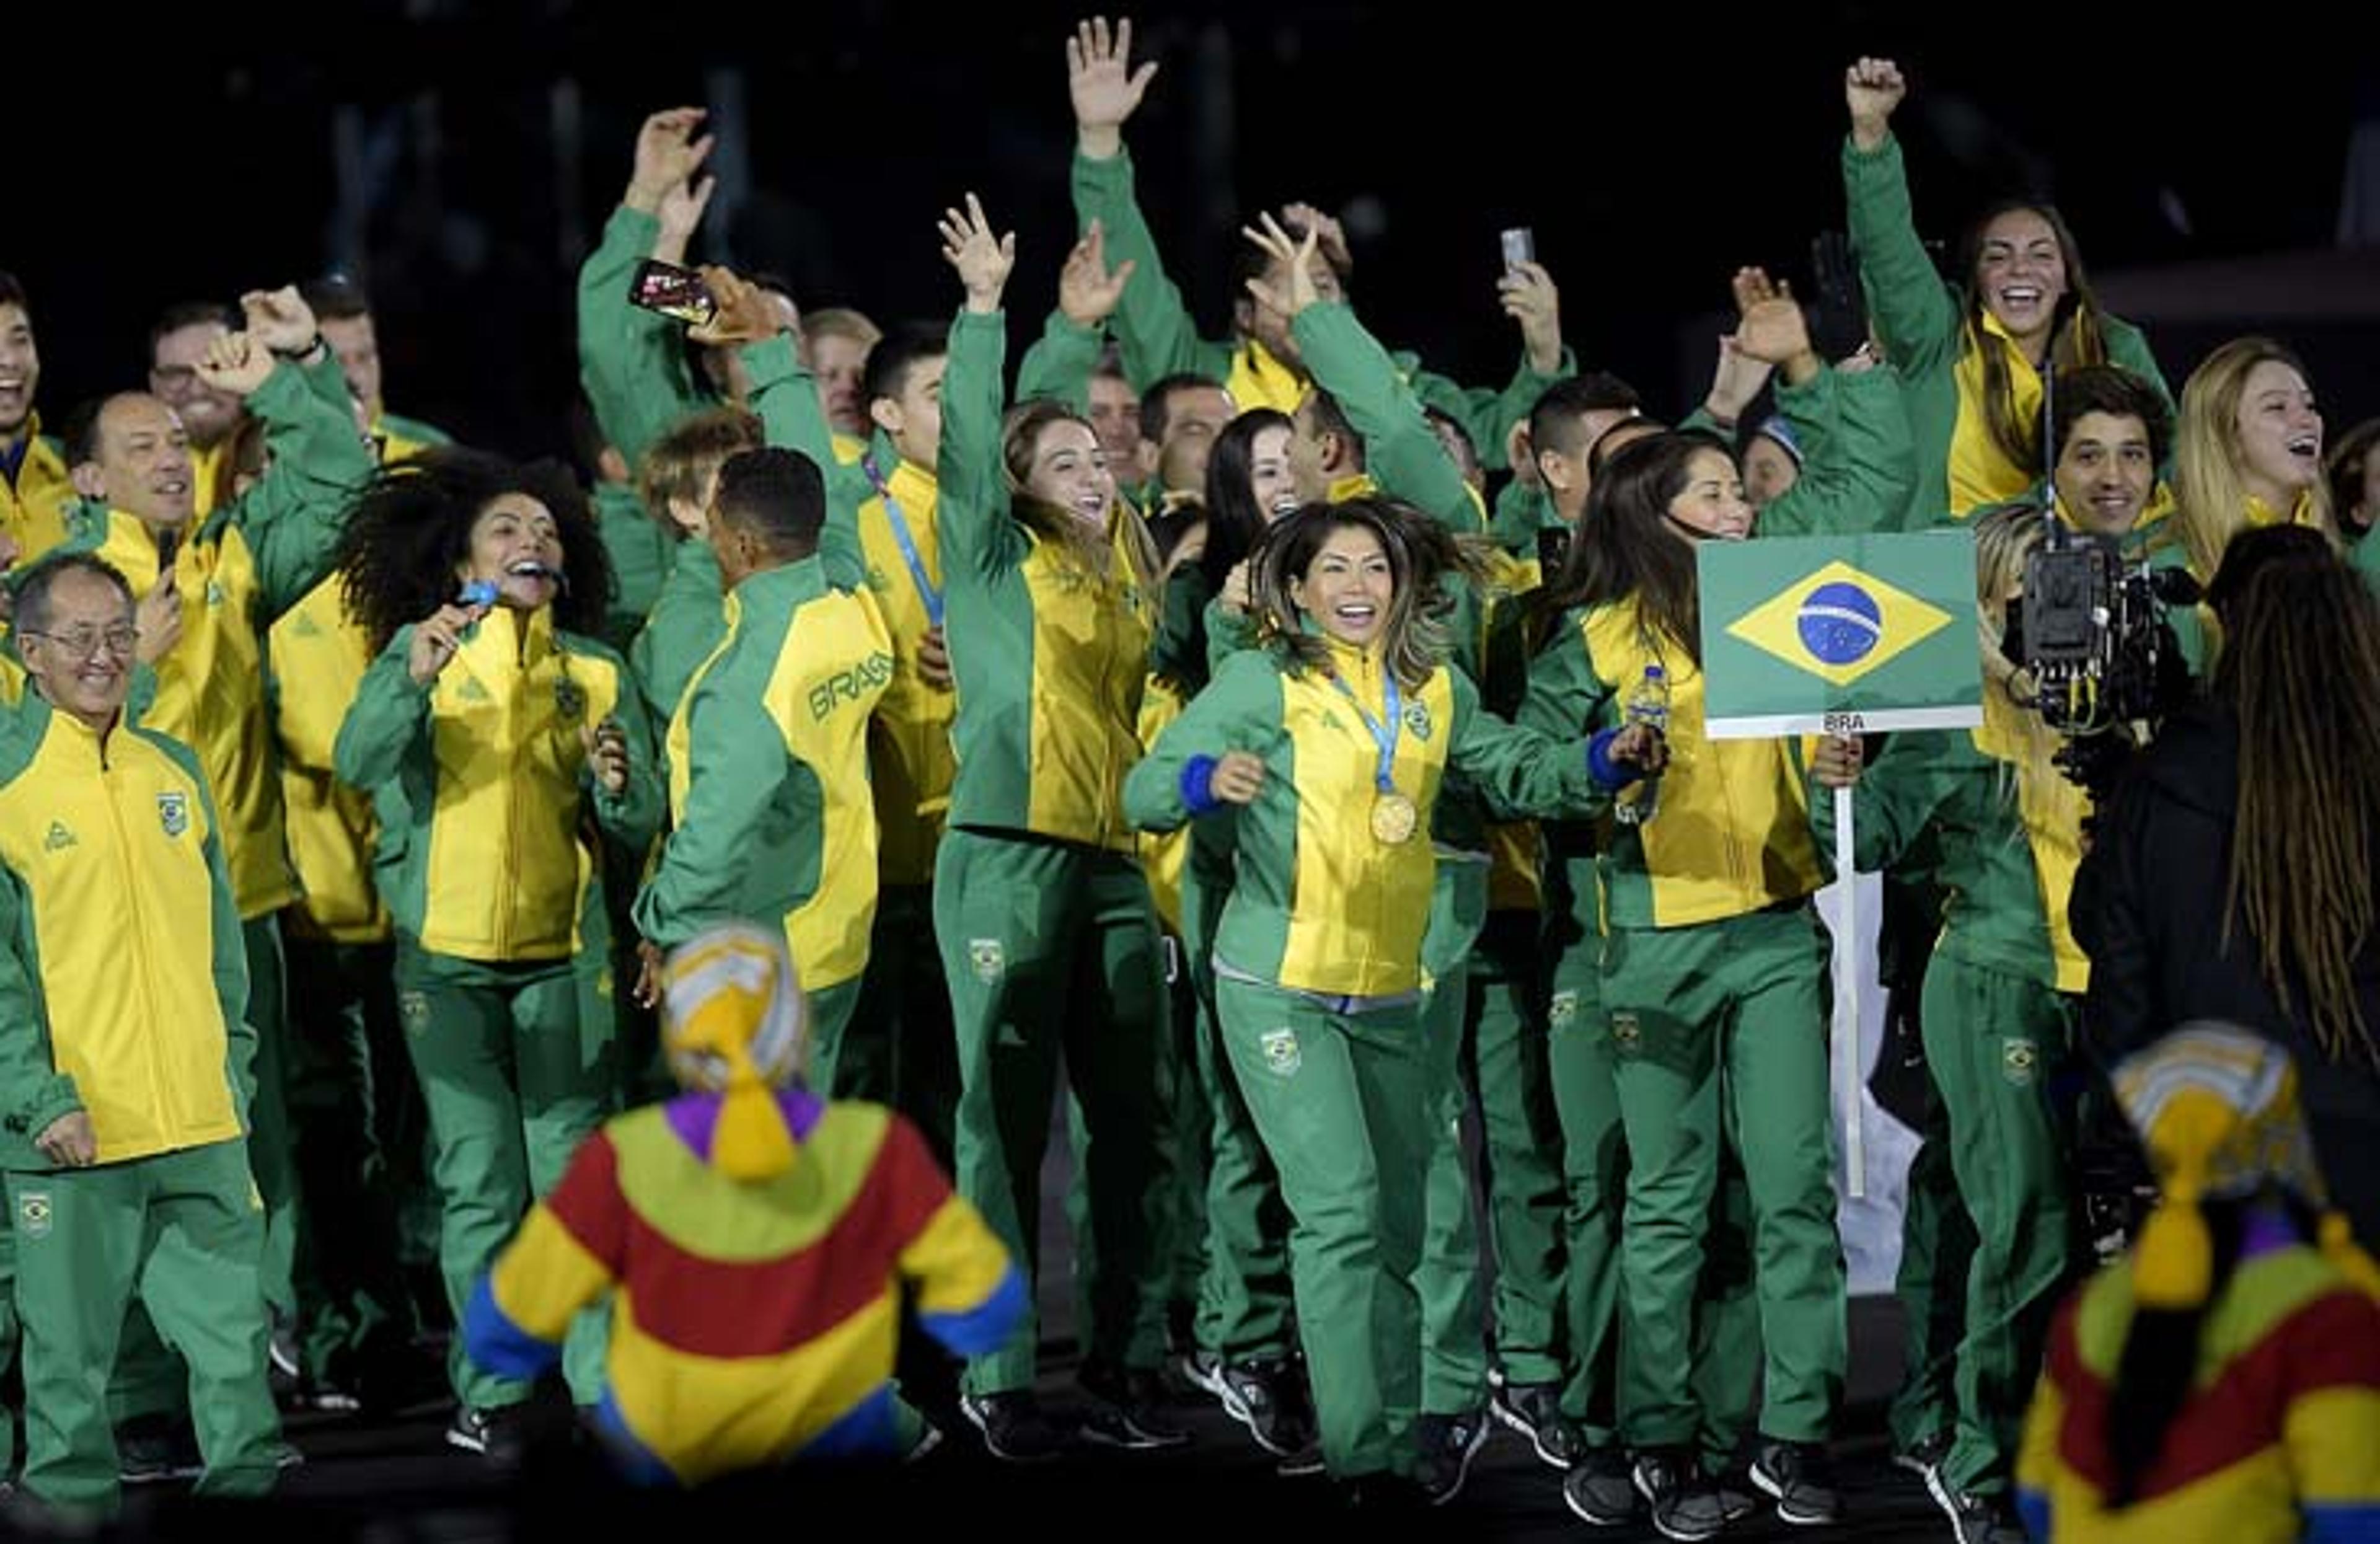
1818 699 2090 1494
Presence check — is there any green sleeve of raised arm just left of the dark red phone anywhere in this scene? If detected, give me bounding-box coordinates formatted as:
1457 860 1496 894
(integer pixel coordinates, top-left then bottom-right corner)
578 205 702 466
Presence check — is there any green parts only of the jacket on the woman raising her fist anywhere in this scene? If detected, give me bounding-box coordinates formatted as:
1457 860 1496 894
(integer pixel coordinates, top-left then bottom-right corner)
1842 136 2173 531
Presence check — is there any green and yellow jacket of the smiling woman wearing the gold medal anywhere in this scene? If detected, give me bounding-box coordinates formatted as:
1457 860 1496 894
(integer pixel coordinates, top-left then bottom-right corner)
1123 642 1609 999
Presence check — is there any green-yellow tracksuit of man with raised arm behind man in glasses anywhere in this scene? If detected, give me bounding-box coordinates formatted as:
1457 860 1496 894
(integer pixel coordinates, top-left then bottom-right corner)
67 352 374 1332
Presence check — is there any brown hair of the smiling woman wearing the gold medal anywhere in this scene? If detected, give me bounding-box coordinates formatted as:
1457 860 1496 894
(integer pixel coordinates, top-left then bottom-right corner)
1247 495 1468 690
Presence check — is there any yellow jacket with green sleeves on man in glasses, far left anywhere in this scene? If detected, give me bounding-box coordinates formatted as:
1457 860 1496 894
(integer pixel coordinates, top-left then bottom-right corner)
0 695 255 1170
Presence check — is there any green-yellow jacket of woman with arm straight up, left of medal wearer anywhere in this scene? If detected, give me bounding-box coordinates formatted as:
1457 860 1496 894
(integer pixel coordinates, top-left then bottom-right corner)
933 314 1157 852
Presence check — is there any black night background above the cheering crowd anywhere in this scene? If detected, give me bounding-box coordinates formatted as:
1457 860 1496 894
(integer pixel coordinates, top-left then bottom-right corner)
19 0 2380 464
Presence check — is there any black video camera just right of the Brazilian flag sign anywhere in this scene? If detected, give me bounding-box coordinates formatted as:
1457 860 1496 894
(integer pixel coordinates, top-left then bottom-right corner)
2006 526 2199 801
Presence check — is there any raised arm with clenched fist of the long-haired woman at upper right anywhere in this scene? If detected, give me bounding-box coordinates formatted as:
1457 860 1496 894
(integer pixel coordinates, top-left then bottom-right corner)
1842 60 1959 374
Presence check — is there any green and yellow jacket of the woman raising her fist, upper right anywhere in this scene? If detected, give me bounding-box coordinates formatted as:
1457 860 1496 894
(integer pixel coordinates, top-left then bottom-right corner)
1842 136 2173 531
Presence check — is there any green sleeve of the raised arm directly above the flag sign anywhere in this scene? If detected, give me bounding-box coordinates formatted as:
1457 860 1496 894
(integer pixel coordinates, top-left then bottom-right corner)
1759 364 1918 536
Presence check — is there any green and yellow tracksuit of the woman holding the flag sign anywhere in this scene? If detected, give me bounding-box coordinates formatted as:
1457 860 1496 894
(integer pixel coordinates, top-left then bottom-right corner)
1521 602 1844 1447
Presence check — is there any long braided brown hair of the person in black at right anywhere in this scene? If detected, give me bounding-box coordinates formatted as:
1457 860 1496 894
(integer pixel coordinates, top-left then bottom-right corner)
2209 526 2380 1061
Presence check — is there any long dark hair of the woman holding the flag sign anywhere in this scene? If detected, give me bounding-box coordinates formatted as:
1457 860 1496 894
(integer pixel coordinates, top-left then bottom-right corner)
1540 431 1735 664
